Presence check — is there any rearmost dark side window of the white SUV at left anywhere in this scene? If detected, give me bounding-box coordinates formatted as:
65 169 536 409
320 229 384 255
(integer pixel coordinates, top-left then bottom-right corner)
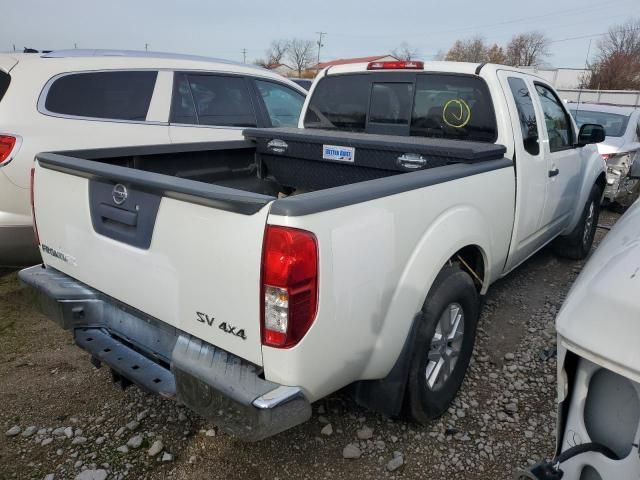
44 71 158 121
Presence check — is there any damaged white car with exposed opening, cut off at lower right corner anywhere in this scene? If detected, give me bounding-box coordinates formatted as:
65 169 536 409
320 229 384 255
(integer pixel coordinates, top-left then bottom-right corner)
519 193 640 480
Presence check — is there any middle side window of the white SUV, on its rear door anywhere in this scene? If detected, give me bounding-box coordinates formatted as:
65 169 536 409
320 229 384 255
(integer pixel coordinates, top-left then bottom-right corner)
185 74 256 127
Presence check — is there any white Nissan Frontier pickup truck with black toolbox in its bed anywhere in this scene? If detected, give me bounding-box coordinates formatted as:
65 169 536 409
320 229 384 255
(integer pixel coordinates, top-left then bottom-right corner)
20 62 605 440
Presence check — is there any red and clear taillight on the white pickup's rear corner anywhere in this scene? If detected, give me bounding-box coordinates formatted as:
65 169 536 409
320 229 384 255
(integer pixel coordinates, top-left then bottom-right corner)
261 225 318 348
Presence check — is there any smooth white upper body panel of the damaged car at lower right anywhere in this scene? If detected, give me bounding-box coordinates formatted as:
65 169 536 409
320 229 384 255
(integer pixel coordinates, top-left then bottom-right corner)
556 201 640 376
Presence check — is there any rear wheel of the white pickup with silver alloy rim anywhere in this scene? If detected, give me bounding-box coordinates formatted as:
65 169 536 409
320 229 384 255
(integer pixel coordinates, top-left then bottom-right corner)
407 266 480 423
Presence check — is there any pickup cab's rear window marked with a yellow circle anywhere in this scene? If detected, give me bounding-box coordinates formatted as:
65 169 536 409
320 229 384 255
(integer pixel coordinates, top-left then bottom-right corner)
304 72 497 142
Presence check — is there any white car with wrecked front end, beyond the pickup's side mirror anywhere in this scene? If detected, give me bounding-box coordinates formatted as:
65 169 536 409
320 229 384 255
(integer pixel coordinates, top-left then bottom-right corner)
569 103 640 207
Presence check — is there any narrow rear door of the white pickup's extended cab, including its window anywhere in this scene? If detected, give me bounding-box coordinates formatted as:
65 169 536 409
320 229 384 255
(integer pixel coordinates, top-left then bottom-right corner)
499 72 548 271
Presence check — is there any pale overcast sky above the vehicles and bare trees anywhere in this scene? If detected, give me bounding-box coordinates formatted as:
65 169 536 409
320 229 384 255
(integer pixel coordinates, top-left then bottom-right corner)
0 0 640 67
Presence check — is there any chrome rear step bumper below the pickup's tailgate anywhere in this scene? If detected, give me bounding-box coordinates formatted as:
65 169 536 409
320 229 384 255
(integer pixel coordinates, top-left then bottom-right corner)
19 265 311 441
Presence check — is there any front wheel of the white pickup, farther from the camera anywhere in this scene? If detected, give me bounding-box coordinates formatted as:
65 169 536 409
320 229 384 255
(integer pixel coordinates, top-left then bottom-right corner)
553 185 602 260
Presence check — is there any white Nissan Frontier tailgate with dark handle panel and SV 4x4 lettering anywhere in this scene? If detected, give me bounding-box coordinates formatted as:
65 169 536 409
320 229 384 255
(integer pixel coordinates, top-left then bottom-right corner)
34 154 272 365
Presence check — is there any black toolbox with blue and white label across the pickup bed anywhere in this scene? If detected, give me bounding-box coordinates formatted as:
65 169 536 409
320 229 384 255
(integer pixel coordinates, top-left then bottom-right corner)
243 128 506 189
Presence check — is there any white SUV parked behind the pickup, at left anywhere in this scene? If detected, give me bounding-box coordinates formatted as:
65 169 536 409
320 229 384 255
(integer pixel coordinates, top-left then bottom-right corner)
0 50 306 265
